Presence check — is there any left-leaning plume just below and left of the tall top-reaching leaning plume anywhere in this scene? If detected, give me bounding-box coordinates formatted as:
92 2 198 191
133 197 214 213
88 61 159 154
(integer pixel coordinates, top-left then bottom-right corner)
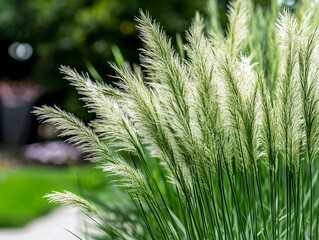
112 65 178 168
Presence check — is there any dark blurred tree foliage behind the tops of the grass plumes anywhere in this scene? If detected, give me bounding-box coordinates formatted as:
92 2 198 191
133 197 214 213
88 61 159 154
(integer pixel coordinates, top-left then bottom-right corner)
0 0 298 143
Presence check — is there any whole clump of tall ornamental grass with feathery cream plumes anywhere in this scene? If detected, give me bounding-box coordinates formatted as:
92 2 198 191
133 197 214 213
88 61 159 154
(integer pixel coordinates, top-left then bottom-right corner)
34 0 319 240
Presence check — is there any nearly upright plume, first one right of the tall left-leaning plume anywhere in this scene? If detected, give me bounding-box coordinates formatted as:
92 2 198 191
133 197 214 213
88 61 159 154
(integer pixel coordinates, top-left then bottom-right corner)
185 14 221 171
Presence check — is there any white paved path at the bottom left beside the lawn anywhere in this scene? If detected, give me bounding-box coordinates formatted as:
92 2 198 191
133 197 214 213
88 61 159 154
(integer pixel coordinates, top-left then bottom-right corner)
0 207 85 240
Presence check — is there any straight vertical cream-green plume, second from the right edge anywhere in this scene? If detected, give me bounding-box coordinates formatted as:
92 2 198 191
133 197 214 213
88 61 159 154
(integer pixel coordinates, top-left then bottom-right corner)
277 10 303 176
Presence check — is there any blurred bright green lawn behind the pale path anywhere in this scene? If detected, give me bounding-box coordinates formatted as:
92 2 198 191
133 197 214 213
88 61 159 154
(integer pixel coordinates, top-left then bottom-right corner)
0 166 106 227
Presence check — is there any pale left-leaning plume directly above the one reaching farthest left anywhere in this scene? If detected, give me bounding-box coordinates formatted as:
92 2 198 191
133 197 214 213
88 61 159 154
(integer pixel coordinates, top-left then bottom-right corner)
61 67 143 154
